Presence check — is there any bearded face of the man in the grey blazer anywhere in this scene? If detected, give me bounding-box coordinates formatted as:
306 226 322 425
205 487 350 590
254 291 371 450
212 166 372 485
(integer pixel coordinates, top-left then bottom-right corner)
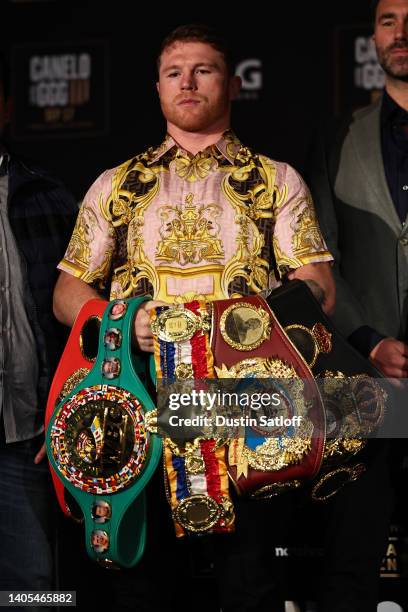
373 0 408 81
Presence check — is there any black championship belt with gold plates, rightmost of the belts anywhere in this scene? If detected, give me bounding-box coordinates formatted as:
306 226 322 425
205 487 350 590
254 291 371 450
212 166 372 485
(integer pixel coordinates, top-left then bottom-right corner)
268 280 387 500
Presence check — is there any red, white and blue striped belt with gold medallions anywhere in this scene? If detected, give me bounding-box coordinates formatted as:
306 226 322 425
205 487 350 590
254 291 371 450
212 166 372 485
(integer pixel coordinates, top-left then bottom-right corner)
151 300 234 537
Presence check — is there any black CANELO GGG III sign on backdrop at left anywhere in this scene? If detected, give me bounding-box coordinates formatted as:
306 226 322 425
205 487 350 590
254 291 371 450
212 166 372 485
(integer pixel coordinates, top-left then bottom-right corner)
12 41 108 139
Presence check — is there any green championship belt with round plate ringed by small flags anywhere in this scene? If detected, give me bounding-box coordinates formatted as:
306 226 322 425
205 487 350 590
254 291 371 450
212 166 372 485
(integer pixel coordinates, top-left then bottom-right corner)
46 297 162 567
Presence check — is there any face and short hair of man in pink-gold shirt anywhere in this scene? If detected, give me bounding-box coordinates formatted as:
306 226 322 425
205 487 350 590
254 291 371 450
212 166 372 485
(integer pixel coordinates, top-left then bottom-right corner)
157 42 240 133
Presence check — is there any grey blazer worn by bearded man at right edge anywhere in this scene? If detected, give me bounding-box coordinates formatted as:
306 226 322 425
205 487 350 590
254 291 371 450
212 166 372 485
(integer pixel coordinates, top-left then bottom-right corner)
309 99 408 339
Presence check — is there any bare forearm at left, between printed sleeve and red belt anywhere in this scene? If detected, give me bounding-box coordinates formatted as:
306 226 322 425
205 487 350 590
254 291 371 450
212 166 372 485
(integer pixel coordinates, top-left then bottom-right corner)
53 272 101 327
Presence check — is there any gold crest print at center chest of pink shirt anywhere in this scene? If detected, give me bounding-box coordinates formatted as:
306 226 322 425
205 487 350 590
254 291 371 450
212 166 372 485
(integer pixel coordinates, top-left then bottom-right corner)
156 193 224 266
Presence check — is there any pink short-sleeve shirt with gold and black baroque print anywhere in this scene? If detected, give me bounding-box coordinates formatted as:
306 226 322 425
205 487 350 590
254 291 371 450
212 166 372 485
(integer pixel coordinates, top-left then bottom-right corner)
59 131 332 303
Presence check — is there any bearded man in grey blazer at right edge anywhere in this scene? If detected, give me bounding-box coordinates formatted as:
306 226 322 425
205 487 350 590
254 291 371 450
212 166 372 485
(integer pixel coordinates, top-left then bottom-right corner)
309 0 408 378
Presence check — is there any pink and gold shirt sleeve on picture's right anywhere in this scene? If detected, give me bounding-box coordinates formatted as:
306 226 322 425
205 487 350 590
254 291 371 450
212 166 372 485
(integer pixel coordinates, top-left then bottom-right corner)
273 164 333 277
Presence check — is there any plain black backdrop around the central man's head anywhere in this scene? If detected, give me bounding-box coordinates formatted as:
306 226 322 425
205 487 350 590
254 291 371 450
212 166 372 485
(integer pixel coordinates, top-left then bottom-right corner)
1 0 370 198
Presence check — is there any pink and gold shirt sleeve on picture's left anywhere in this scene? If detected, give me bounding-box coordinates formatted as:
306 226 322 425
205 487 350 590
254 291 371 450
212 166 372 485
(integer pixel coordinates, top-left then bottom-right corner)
58 169 116 290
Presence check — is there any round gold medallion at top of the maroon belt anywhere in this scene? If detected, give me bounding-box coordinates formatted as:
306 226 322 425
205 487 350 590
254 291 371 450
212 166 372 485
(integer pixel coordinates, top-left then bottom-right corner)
220 302 271 351
